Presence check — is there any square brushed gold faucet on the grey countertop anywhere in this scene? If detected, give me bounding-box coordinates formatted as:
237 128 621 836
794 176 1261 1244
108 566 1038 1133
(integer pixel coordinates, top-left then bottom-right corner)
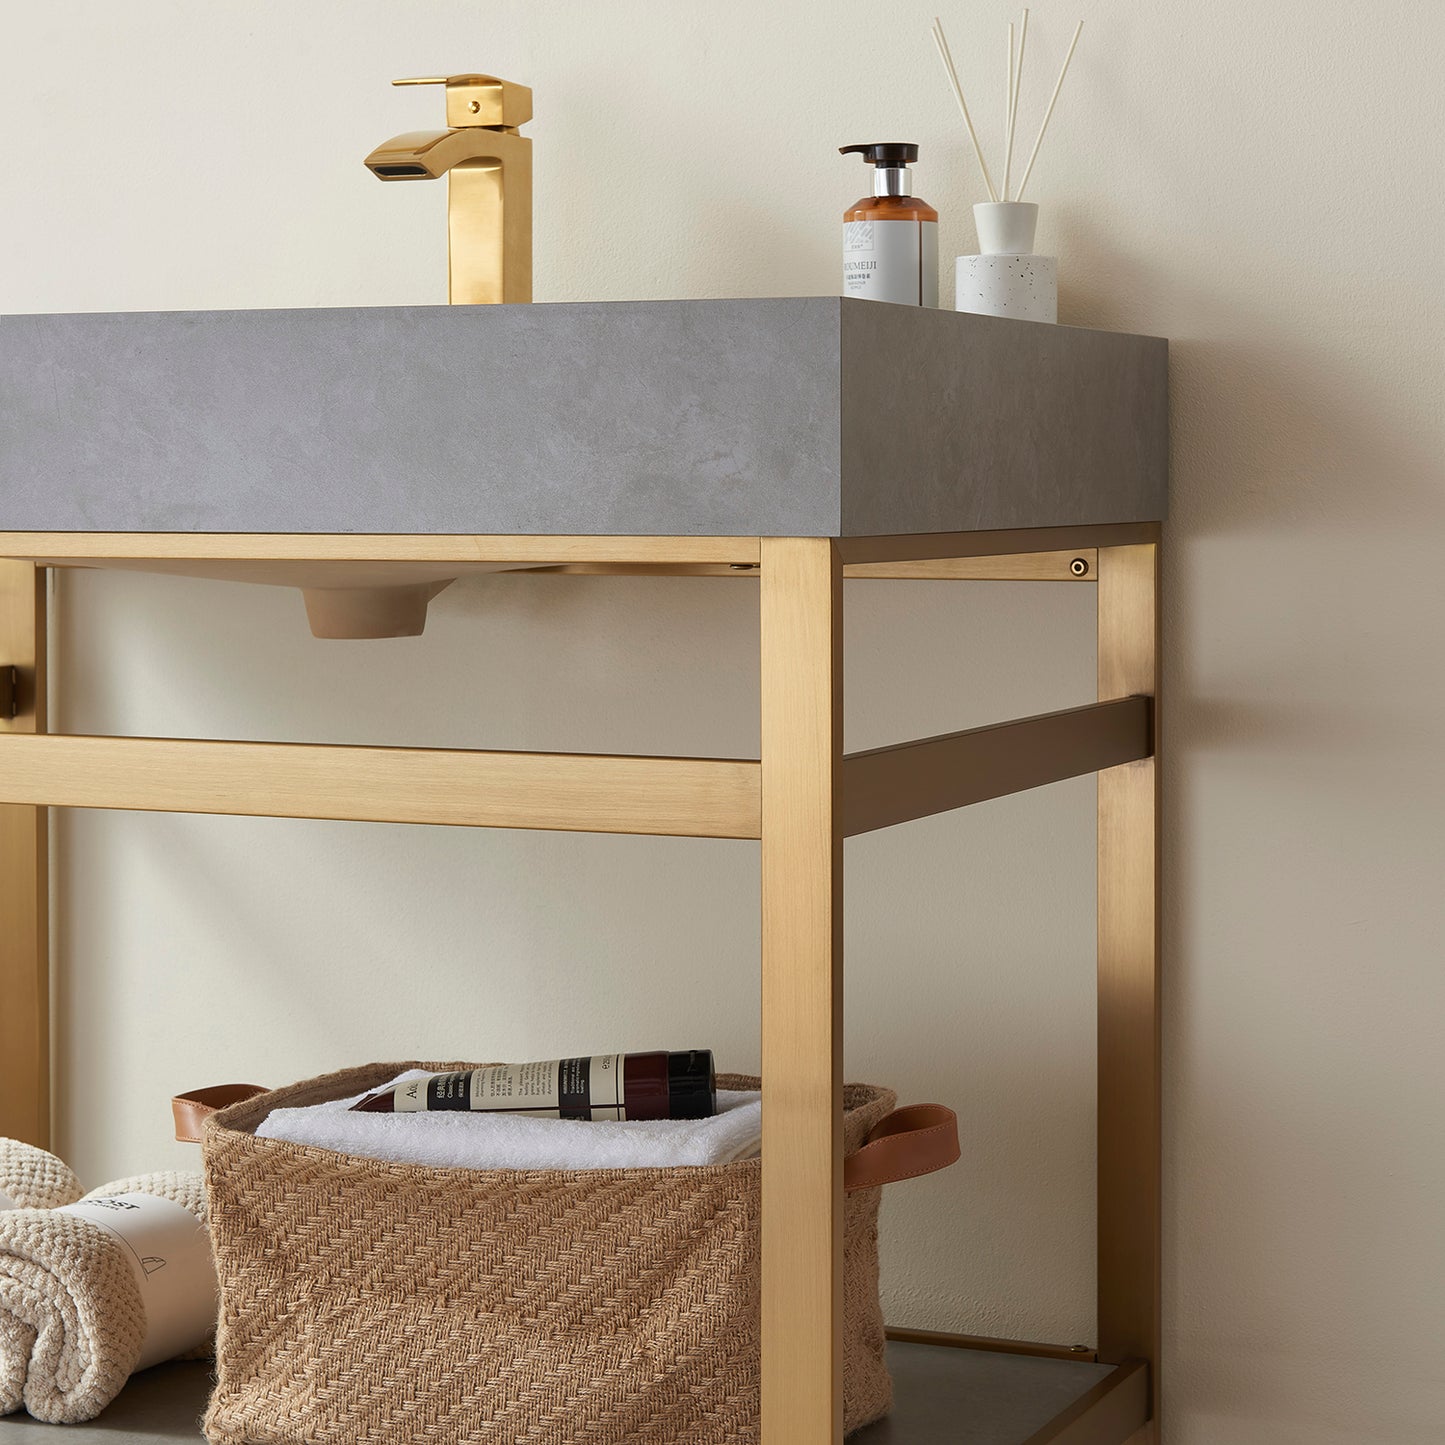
366 75 532 305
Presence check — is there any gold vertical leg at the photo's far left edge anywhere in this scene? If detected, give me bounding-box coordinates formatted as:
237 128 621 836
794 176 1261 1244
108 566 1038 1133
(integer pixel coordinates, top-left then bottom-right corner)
0 562 51 1146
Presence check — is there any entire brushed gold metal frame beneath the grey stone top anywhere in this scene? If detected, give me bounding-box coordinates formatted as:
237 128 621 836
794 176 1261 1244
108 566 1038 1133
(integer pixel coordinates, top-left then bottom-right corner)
0 525 1160 1445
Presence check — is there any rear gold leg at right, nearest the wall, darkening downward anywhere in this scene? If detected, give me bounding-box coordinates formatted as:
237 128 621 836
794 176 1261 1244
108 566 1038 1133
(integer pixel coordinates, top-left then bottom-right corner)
1098 545 1160 1445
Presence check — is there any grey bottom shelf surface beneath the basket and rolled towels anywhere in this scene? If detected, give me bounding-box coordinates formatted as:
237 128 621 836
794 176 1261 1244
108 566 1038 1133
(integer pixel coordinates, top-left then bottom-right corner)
0 1344 1111 1445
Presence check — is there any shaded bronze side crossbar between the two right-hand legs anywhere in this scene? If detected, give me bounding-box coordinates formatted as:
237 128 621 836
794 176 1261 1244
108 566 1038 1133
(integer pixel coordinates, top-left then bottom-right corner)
842 696 1153 838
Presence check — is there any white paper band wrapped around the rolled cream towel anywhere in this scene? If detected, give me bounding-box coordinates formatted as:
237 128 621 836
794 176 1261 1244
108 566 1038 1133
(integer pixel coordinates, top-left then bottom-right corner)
58 1194 217 1370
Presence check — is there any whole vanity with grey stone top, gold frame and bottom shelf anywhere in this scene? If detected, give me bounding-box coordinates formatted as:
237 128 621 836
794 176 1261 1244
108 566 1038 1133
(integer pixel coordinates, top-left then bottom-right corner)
0 298 1168 1445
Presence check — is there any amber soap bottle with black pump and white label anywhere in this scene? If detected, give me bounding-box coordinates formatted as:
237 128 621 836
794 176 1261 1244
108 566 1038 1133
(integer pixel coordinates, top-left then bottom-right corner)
838 140 938 306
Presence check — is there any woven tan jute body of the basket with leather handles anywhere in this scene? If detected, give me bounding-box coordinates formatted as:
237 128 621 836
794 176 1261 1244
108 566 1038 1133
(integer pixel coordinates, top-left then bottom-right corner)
202 1064 894 1445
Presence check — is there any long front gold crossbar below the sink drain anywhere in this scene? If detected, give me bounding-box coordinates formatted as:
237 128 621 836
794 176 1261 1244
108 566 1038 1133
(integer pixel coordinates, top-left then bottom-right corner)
0 734 762 838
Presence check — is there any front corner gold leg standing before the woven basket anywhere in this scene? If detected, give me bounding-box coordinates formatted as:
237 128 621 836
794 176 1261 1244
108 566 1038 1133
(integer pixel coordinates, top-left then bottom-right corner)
762 538 842 1445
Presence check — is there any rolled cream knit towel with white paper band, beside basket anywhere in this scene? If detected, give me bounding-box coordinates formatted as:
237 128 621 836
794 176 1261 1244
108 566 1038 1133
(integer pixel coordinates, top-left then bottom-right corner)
0 1173 215 1433
